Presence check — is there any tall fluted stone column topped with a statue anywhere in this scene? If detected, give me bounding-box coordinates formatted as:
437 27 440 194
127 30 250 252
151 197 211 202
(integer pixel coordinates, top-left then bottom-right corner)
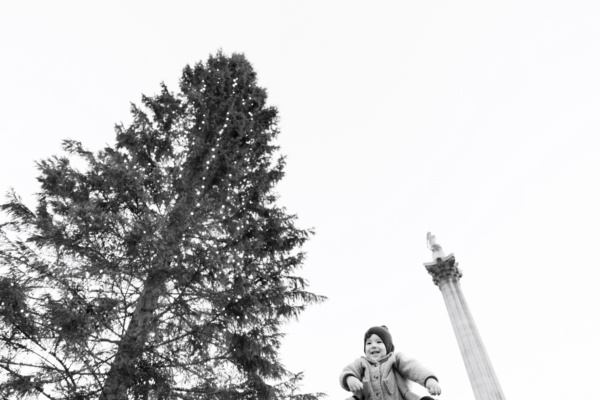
425 233 505 400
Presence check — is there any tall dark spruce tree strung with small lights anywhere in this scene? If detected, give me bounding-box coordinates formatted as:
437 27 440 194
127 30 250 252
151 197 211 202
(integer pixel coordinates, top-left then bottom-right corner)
0 53 323 400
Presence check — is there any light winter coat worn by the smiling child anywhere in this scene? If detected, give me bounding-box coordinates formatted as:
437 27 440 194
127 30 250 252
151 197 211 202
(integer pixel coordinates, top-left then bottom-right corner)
340 353 437 400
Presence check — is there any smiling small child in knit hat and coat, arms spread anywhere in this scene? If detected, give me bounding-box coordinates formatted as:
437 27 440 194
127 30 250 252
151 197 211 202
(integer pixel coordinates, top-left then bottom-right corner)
340 326 442 400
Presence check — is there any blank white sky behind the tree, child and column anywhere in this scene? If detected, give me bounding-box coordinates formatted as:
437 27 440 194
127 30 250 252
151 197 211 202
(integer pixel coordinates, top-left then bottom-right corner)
0 0 600 400
